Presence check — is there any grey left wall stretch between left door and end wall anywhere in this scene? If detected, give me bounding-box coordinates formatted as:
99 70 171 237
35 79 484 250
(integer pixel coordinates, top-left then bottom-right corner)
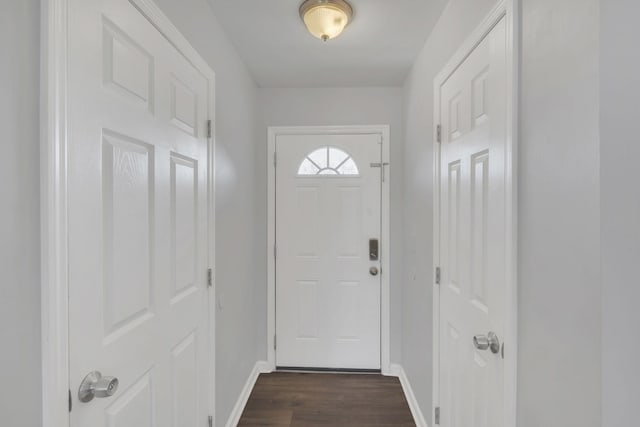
143 0 264 425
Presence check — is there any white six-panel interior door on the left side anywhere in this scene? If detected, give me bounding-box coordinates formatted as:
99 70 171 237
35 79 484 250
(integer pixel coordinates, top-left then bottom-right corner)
68 0 210 427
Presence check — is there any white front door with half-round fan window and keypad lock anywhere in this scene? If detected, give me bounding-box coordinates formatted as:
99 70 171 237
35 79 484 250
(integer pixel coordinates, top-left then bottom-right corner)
276 135 383 369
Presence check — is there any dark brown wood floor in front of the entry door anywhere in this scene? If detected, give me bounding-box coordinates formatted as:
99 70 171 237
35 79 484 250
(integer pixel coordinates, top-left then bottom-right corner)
238 372 415 427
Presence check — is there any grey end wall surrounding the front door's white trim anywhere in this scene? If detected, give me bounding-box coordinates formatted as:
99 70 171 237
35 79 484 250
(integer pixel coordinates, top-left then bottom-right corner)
256 88 404 363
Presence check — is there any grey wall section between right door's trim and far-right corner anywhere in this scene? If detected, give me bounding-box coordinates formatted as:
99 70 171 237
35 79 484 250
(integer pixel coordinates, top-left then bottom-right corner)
518 0 608 427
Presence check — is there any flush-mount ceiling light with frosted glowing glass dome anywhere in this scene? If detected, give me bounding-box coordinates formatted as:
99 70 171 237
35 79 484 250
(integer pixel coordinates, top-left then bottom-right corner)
300 0 353 41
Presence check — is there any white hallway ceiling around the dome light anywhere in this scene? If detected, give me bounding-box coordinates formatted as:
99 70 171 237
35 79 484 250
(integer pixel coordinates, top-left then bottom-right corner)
209 0 447 87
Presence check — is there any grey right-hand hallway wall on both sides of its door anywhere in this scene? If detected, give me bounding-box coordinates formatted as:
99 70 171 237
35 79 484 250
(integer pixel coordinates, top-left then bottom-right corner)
402 0 601 427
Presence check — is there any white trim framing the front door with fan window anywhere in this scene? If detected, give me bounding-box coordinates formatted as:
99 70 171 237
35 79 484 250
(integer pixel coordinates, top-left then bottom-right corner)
267 125 393 375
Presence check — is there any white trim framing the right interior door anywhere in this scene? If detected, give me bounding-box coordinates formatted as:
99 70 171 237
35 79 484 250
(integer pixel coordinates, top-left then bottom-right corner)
430 0 520 427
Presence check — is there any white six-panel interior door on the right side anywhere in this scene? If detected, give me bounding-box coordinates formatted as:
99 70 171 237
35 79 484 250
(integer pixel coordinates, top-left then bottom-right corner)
439 18 507 427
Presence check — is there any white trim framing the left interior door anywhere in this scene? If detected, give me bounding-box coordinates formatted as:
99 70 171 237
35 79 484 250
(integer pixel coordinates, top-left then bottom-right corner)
40 0 215 427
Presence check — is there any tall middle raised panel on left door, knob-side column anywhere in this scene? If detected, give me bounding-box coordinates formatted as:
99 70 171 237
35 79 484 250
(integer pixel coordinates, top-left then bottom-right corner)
102 131 155 340
